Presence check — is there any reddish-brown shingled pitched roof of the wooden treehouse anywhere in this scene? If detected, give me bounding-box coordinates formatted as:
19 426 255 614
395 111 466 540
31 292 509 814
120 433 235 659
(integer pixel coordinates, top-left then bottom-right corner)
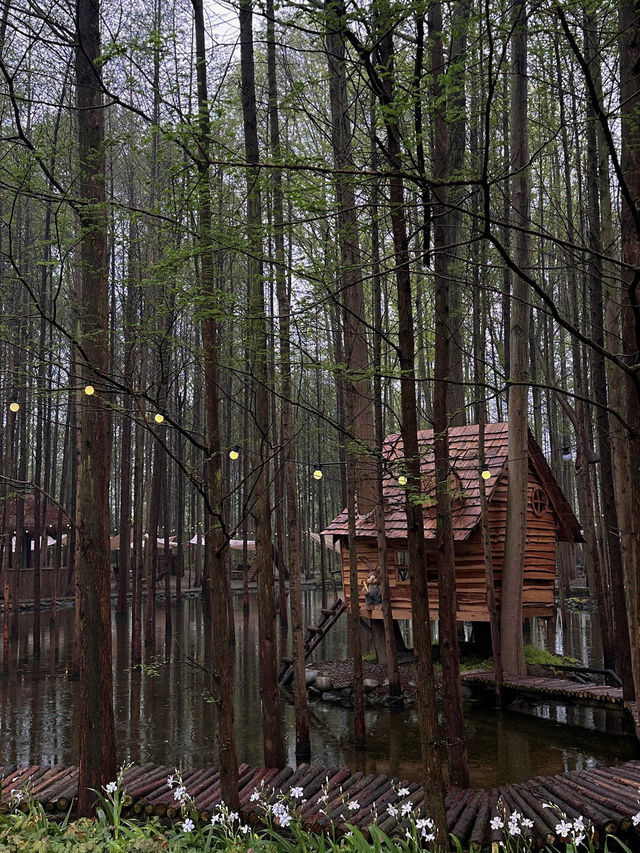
324 423 582 543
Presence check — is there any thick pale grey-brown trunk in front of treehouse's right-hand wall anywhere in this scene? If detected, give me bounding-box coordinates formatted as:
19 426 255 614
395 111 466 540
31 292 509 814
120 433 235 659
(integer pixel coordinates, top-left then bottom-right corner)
500 0 530 674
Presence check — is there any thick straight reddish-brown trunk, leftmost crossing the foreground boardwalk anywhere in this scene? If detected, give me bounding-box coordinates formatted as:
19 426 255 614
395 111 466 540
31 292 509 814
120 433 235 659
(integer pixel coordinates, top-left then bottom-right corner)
75 0 116 817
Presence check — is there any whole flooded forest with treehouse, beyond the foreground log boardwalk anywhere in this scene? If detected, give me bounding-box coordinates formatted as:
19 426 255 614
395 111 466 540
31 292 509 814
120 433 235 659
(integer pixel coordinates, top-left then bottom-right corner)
0 0 640 829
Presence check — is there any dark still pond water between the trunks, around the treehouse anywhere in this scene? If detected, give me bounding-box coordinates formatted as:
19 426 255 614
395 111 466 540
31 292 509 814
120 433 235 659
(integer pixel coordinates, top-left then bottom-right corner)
0 591 638 787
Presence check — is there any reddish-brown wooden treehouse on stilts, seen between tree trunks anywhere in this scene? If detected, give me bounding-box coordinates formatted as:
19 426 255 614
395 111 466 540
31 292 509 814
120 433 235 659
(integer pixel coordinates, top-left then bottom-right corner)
324 423 582 622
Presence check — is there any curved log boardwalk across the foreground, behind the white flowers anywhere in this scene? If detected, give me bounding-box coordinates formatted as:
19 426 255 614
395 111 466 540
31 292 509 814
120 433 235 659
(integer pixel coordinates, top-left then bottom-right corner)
0 761 640 851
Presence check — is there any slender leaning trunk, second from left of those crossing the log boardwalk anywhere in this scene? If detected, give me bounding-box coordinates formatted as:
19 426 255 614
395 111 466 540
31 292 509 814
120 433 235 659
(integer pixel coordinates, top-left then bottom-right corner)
192 0 239 810
